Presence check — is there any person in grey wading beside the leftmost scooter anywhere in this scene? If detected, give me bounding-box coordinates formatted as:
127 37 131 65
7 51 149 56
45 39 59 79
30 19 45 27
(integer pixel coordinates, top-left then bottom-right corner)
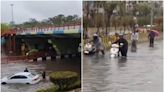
93 34 105 55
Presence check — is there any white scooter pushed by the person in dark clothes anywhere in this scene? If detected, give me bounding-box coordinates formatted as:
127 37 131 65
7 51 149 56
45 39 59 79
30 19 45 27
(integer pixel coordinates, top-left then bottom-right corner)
110 44 119 58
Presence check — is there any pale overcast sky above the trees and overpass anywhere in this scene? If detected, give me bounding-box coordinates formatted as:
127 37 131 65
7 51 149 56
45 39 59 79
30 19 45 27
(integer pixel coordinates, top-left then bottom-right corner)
1 1 82 24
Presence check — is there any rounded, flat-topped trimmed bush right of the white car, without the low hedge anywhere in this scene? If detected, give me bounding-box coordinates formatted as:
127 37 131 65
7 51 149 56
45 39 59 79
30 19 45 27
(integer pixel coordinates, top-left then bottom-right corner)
49 71 78 90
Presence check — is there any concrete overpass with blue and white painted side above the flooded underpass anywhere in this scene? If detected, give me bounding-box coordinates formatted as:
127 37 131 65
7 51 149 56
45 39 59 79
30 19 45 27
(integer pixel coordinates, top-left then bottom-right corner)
2 25 82 55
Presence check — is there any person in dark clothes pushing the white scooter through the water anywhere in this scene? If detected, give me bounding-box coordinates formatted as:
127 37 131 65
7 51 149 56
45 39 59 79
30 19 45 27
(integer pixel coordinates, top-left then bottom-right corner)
114 35 128 57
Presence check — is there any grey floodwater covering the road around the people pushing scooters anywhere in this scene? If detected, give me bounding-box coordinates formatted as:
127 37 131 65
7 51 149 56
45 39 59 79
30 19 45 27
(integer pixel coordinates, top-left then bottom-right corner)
83 41 163 92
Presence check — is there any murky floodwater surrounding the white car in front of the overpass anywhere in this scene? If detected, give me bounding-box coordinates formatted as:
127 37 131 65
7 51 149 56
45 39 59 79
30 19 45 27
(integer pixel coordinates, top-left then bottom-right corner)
1 58 81 92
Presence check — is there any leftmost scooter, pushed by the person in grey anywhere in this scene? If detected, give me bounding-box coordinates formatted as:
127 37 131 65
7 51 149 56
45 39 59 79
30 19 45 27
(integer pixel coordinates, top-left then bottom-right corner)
84 43 96 55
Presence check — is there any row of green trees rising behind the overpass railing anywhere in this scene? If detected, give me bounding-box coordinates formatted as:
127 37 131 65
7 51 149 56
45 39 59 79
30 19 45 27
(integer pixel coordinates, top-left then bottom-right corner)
16 14 81 28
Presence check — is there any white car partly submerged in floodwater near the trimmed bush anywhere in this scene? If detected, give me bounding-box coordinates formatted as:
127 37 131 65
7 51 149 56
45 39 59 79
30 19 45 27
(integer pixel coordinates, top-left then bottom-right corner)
1 72 41 84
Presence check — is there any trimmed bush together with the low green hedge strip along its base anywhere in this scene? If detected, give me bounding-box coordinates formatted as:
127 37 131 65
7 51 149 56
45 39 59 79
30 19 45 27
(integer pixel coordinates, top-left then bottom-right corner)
37 71 81 92
